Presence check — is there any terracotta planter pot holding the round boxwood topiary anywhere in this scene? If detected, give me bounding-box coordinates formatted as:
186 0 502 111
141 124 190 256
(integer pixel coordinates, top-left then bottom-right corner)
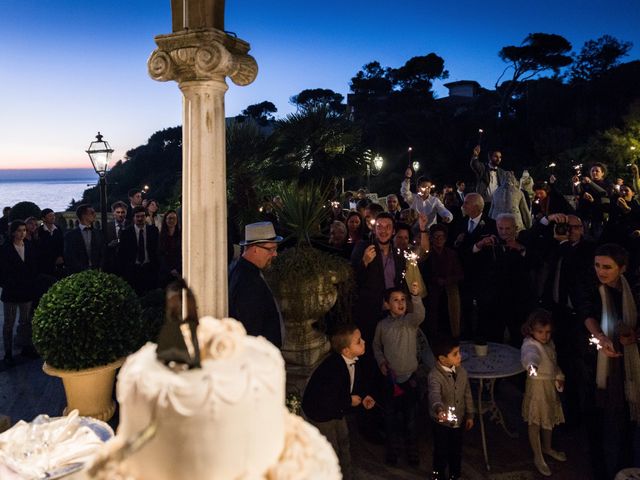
42 358 124 422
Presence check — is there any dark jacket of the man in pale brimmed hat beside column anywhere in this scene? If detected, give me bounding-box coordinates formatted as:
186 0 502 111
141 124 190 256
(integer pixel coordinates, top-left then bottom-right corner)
229 257 282 348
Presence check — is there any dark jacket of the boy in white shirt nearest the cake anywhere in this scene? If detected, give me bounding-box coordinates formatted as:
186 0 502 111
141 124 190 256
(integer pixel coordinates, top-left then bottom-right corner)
302 352 369 422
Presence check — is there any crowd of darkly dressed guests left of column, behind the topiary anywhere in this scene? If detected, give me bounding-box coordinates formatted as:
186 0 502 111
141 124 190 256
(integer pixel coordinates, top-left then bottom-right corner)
0 190 182 367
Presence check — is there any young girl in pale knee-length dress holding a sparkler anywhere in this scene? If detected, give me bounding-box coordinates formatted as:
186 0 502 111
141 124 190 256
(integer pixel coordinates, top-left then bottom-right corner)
520 309 567 477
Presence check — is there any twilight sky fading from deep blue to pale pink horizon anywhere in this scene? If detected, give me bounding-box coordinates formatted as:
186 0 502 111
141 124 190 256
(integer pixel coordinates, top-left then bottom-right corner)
0 0 640 169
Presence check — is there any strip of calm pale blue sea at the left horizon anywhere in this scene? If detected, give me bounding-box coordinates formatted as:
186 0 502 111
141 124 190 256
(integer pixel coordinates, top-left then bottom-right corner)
0 169 97 212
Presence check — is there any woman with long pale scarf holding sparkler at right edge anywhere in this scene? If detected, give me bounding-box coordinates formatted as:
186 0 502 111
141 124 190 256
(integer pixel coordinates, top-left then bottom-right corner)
584 243 640 478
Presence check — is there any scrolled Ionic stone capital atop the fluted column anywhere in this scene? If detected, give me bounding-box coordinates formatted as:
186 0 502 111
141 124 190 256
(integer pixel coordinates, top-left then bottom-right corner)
147 28 258 86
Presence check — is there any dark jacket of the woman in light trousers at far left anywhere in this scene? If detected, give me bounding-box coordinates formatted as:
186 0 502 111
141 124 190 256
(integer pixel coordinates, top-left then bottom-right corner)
0 240 37 303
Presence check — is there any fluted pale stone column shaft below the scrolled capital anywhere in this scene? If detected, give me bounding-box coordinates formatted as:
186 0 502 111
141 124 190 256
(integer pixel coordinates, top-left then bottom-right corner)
180 76 228 318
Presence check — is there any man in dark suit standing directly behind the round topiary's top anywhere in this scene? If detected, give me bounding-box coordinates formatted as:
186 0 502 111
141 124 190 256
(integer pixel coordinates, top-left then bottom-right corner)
64 204 103 273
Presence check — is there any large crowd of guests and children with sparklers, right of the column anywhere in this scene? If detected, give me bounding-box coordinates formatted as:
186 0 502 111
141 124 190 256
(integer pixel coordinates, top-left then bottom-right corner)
303 146 640 479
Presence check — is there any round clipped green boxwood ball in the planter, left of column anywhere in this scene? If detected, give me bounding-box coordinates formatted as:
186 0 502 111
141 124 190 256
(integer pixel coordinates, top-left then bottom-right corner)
33 270 146 370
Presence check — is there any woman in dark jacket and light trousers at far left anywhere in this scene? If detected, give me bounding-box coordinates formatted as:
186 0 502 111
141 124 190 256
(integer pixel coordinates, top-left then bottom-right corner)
0 220 37 366
